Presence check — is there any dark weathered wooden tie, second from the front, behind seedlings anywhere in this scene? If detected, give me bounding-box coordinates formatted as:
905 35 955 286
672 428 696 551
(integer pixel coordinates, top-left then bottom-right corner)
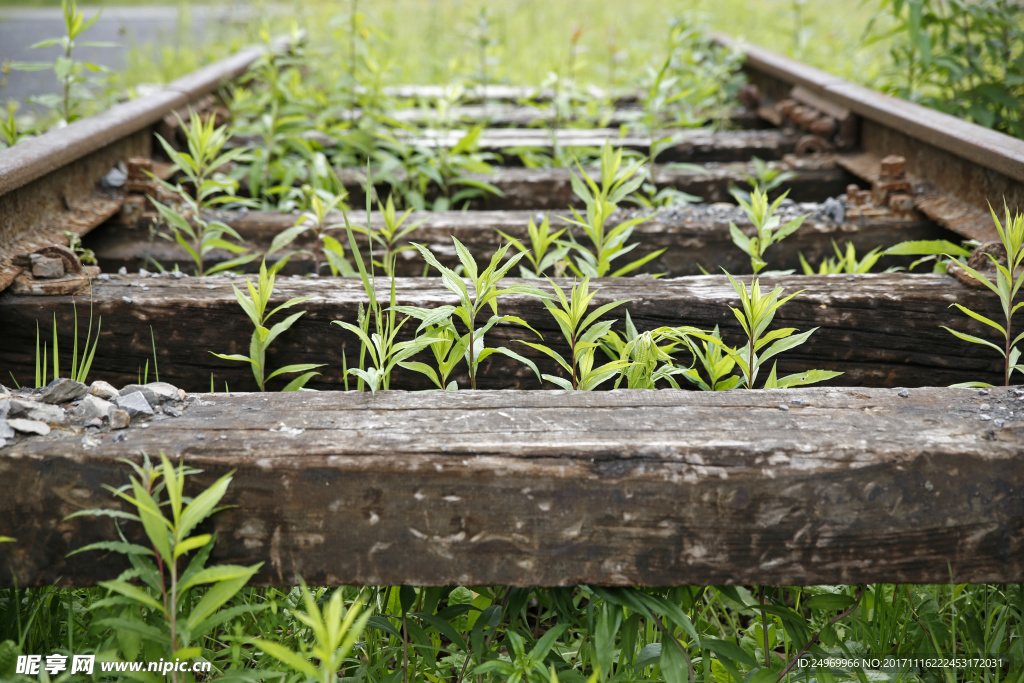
0 273 1002 391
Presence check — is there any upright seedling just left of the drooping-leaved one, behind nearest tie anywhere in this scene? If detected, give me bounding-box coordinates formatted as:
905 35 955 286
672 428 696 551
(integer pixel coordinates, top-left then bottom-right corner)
519 278 630 391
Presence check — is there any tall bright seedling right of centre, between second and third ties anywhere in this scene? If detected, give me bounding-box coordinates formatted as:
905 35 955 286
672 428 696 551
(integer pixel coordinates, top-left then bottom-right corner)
562 141 665 278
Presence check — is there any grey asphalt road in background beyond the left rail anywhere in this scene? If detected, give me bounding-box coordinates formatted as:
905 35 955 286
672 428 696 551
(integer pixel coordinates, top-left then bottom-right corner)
0 3 250 102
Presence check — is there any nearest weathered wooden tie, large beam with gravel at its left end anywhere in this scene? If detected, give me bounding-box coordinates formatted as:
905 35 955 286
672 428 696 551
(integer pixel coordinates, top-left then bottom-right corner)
0 388 1024 586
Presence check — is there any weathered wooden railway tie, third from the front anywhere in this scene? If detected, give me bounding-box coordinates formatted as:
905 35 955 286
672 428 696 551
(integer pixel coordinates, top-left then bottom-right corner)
85 205 955 276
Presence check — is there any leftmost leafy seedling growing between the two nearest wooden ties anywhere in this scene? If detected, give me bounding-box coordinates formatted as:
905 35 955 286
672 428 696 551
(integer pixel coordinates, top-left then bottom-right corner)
211 262 324 391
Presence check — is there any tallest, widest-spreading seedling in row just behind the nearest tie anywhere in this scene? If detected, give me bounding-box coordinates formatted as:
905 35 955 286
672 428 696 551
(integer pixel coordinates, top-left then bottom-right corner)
395 237 548 389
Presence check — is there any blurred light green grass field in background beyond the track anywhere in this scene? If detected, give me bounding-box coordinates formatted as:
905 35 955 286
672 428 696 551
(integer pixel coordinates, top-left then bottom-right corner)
288 0 882 85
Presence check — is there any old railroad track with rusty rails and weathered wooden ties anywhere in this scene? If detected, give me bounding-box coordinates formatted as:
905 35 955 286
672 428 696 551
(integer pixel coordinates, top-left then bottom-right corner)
0 38 1024 586
